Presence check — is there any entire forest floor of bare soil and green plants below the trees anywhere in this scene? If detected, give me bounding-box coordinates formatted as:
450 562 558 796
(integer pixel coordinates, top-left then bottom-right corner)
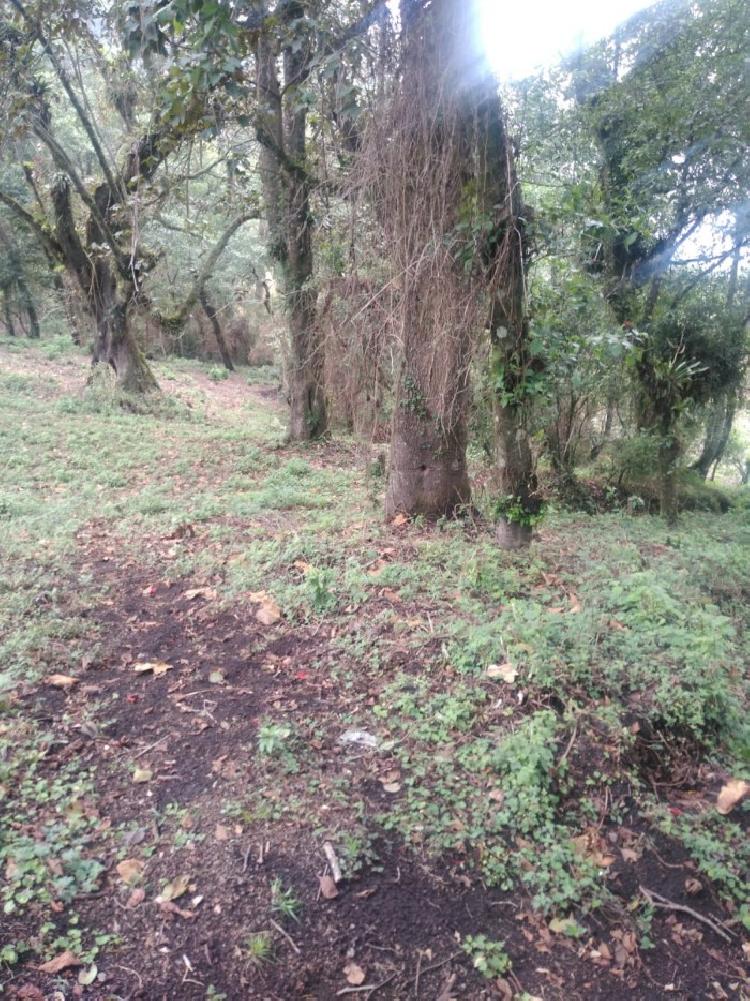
0 341 750 1001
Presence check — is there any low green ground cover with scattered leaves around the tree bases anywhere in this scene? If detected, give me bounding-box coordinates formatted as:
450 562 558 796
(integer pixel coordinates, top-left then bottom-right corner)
0 344 750 977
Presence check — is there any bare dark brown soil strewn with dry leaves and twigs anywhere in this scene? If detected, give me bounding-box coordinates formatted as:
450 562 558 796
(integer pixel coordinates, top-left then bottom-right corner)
0 346 748 1001
